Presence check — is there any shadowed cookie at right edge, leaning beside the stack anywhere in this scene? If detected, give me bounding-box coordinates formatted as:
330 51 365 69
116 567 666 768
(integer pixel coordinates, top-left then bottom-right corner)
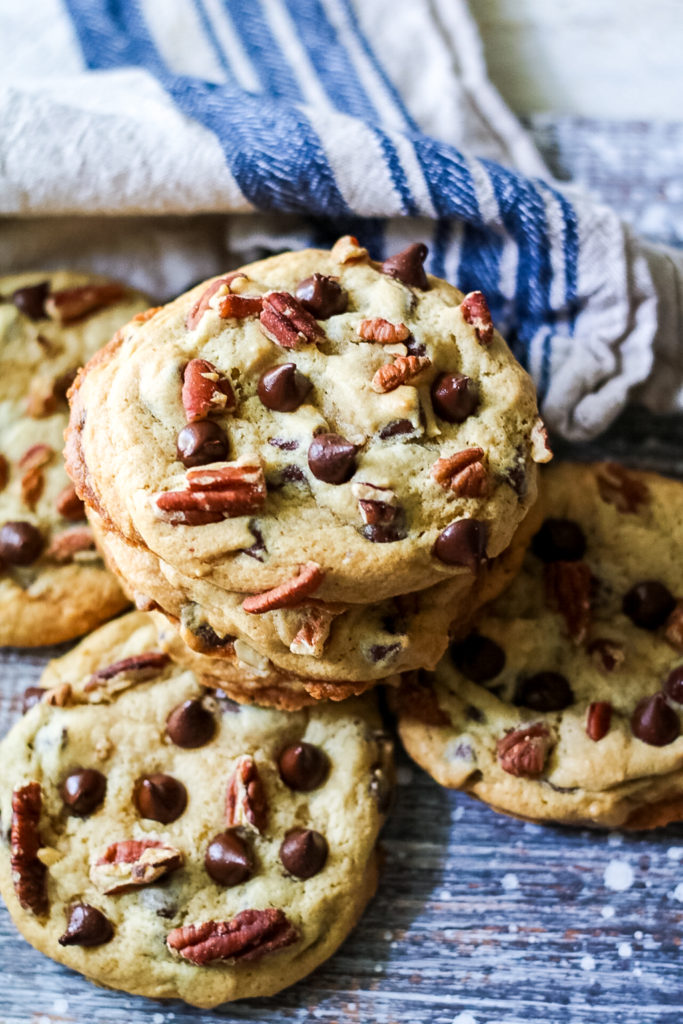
398 463 683 828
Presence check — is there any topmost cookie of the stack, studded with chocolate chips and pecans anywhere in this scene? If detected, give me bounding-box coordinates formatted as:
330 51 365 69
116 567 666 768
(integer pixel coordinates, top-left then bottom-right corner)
67 239 549 616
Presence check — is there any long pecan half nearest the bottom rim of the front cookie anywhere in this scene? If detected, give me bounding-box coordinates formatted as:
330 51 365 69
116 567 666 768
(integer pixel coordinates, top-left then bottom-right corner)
166 907 299 967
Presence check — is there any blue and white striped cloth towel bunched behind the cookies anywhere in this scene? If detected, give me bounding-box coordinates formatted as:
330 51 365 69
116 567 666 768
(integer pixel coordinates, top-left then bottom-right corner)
0 0 683 438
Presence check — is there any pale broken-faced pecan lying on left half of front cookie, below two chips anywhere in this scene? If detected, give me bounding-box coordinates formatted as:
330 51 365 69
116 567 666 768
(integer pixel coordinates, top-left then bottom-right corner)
90 839 182 896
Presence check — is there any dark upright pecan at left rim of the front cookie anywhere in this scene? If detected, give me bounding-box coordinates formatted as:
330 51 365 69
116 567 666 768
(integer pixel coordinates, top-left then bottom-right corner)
9 782 48 914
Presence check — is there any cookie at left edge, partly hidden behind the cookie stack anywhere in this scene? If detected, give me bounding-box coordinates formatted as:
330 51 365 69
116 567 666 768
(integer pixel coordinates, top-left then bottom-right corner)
0 271 147 646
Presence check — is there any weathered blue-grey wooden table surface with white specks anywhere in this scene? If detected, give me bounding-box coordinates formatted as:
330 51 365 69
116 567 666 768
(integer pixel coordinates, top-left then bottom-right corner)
0 119 683 1024
